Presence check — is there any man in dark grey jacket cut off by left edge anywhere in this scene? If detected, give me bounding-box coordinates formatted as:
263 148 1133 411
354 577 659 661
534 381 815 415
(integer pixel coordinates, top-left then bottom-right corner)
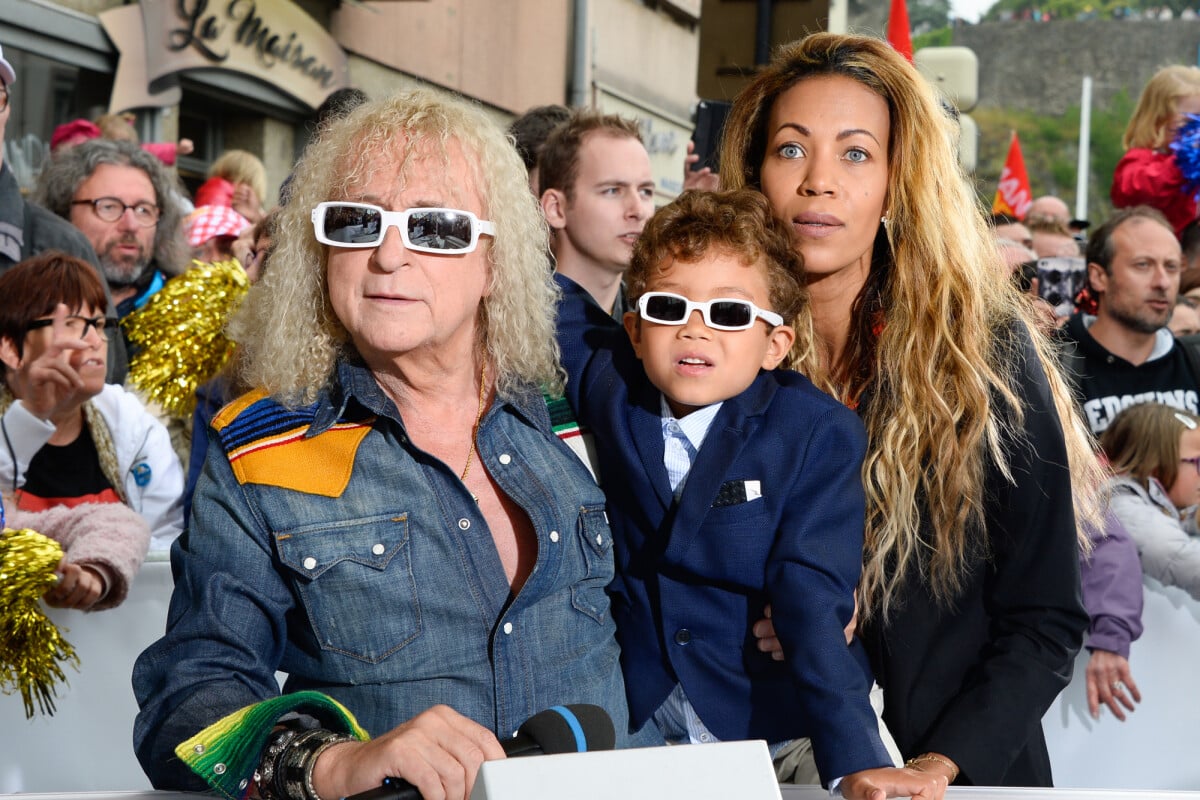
0 40 128 383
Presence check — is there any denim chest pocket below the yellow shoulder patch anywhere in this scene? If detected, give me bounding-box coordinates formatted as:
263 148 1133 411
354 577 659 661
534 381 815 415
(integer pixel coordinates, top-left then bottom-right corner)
275 513 421 663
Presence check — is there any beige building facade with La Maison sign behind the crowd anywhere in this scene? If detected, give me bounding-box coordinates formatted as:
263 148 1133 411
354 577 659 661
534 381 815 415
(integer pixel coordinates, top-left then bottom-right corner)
0 0 701 203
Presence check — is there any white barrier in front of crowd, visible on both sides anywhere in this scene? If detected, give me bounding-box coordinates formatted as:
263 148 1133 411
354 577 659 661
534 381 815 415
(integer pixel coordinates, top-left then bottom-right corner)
0 560 1200 796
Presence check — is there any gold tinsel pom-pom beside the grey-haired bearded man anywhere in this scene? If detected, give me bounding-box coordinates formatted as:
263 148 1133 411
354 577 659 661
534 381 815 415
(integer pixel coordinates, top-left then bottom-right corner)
121 260 250 417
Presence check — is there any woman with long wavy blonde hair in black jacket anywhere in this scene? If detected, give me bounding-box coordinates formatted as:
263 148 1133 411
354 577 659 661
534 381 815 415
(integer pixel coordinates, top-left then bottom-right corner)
721 34 1099 786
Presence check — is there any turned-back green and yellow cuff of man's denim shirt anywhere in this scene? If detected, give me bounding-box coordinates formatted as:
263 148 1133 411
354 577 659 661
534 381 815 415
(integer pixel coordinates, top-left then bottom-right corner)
175 692 370 800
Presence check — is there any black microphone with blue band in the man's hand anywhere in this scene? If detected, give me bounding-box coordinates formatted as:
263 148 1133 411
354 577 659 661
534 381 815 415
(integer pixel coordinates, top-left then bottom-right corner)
346 703 617 800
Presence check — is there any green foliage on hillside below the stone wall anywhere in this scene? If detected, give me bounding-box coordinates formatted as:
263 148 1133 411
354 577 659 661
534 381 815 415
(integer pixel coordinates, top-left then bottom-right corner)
971 90 1134 221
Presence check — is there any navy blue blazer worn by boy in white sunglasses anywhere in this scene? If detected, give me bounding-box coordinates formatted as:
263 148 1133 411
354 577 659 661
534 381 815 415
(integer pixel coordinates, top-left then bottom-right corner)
556 276 890 783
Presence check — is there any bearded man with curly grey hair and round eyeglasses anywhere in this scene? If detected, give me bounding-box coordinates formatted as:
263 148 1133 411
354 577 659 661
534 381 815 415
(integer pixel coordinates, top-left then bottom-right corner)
37 139 188 318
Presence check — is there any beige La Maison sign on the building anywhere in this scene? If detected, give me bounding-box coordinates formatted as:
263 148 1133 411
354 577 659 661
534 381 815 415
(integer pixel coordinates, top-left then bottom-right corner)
101 0 349 110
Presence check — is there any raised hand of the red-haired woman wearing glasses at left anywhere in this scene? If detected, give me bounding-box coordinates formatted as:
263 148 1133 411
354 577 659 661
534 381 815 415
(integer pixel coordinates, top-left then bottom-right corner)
6 303 91 421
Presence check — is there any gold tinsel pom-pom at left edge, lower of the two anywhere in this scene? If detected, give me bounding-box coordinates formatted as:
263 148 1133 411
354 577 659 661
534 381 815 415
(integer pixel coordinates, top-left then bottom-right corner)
0 528 79 718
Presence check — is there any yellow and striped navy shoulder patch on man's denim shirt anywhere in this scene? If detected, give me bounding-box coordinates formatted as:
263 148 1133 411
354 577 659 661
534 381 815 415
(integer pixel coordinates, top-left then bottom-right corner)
212 392 373 498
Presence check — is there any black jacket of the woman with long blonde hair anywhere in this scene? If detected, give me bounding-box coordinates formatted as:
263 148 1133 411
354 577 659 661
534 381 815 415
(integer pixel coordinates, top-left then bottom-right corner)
862 321 1088 786
